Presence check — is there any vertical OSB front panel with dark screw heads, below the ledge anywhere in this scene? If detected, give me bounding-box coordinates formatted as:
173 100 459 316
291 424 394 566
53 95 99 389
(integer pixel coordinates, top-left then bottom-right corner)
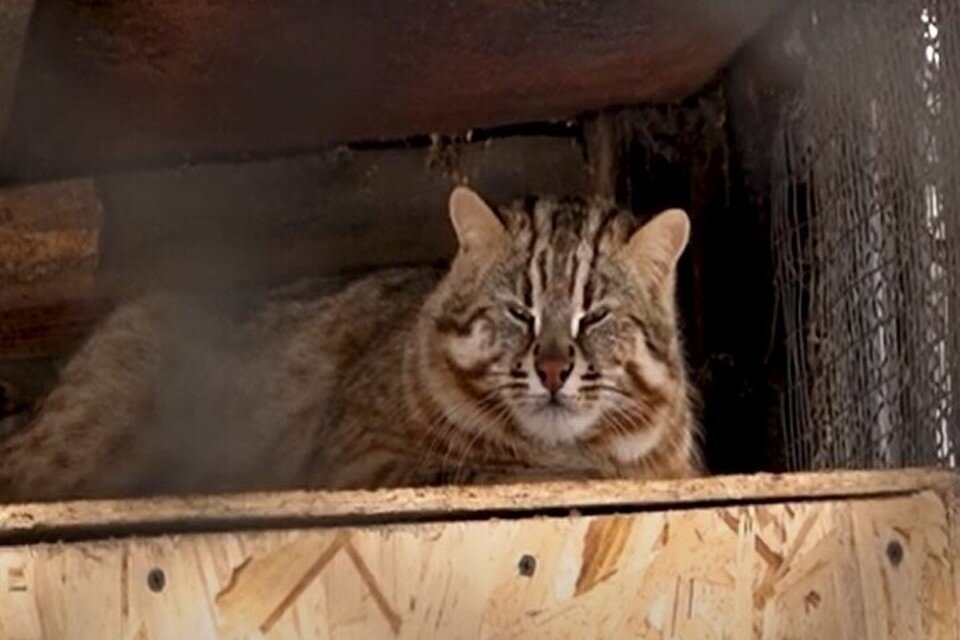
0 491 956 640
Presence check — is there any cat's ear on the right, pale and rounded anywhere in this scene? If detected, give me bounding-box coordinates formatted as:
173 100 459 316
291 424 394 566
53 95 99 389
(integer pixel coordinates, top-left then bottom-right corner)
625 209 690 282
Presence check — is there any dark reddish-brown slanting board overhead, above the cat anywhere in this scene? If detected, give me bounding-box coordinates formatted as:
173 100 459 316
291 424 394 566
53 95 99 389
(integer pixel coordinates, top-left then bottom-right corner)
0 0 781 177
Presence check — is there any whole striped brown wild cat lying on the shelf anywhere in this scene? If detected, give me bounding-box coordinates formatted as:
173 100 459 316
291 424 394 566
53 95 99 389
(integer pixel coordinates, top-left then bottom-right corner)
0 187 699 500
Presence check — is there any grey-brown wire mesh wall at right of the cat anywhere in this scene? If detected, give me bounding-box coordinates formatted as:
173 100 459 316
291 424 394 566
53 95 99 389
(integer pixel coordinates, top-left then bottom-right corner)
771 0 960 469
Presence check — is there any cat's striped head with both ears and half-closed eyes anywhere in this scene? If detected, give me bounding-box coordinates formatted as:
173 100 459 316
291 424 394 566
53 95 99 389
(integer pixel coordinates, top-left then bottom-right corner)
427 187 690 460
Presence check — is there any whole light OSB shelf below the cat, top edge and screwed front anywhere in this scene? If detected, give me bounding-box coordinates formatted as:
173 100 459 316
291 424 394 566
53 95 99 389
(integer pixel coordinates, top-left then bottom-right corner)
0 470 960 640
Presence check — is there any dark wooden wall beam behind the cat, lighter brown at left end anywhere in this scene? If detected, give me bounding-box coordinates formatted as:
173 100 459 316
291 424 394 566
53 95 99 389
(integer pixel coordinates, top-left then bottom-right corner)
0 137 589 359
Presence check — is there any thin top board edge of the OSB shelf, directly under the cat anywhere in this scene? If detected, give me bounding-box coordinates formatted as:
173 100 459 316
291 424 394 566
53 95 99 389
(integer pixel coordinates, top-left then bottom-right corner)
0 469 957 542
